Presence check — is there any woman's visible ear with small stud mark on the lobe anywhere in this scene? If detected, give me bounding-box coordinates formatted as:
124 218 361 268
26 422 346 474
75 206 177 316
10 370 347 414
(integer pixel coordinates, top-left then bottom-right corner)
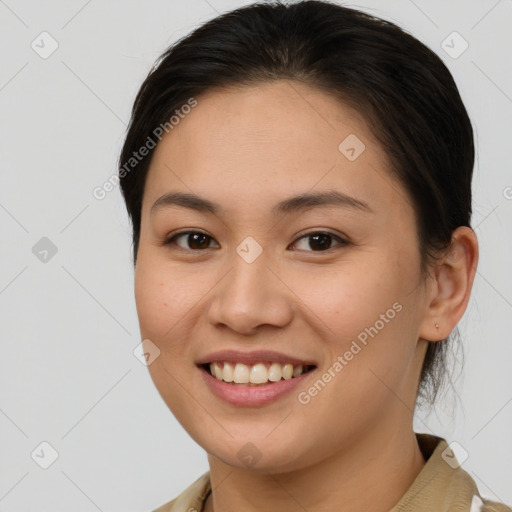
419 226 478 341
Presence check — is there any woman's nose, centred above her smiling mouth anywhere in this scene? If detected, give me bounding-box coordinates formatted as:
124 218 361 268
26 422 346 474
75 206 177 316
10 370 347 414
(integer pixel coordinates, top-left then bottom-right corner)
208 252 293 335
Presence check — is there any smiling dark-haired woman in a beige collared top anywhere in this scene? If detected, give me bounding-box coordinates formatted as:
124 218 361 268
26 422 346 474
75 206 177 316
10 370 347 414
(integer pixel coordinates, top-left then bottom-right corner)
119 1 511 512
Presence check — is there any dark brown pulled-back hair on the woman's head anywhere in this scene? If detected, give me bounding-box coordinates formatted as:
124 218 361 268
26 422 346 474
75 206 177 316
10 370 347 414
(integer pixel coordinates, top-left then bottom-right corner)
119 0 474 404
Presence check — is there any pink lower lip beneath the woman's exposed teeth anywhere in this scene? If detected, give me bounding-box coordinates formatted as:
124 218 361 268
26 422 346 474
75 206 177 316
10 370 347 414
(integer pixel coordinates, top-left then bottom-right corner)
199 366 315 407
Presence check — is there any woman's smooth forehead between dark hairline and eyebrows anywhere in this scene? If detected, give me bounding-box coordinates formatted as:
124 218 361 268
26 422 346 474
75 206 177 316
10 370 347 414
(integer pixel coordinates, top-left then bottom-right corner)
144 80 407 218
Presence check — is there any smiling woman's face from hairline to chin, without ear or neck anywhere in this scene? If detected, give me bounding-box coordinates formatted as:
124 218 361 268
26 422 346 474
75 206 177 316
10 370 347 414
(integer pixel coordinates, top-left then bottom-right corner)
135 81 426 472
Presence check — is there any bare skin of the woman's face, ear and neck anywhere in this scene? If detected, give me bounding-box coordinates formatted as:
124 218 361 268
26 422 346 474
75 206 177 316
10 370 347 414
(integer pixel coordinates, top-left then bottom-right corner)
135 80 478 512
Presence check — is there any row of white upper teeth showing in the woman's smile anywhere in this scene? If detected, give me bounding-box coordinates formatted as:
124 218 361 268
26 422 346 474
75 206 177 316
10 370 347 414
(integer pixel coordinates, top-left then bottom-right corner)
210 361 305 384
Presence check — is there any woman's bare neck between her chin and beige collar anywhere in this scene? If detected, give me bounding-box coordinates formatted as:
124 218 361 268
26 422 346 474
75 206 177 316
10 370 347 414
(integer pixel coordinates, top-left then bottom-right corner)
203 424 425 512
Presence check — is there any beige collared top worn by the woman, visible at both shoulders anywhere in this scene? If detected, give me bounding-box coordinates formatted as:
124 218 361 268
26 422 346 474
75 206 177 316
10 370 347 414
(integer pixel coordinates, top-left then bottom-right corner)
153 433 512 512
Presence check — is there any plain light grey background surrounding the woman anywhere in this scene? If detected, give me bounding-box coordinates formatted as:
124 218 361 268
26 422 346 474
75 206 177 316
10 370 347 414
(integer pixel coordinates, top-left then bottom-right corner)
0 0 512 512
